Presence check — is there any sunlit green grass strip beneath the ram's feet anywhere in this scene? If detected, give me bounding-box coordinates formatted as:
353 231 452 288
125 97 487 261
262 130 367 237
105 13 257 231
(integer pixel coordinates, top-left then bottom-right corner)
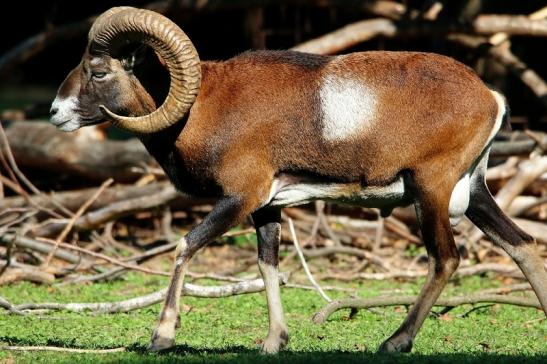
0 274 547 364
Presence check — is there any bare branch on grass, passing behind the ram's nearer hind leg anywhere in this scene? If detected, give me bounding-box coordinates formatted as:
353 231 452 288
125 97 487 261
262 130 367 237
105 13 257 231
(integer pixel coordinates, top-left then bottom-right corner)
313 293 541 324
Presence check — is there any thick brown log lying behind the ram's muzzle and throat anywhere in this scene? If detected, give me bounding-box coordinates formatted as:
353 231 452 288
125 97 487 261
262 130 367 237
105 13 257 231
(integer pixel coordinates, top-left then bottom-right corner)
2 121 154 182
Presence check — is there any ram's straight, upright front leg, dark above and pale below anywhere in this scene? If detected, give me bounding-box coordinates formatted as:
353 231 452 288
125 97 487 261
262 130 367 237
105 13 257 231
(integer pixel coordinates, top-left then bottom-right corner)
252 209 289 354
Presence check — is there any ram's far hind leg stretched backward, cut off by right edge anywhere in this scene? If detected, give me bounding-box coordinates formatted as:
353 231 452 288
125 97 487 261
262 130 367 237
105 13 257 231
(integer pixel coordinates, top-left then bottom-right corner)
466 176 547 315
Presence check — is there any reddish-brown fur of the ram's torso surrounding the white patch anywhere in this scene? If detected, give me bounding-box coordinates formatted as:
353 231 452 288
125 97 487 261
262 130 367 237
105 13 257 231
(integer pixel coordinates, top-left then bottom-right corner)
171 52 497 205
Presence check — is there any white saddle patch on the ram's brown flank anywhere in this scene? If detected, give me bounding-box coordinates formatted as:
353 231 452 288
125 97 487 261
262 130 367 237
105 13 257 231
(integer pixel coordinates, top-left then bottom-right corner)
319 75 376 141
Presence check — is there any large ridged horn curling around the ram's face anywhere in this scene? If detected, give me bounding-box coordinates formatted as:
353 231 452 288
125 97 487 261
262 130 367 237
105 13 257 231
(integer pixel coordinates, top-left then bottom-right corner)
89 7 201 134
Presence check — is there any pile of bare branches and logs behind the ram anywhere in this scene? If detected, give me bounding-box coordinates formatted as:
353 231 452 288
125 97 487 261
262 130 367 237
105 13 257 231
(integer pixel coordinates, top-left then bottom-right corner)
0 1 547 328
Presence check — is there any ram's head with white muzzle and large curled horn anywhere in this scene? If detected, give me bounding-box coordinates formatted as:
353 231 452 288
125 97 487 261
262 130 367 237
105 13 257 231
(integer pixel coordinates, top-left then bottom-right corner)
50 7 201 134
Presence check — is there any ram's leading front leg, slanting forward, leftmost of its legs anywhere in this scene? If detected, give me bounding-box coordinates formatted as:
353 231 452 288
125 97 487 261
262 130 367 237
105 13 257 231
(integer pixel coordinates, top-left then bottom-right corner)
149 197 254 351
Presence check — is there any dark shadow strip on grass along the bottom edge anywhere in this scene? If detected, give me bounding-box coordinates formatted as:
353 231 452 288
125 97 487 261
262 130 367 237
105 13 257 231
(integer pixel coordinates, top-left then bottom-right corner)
0 337 547 364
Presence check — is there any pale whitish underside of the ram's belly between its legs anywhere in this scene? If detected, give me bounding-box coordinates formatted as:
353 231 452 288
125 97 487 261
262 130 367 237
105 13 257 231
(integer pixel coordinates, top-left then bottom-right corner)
266 177 405 208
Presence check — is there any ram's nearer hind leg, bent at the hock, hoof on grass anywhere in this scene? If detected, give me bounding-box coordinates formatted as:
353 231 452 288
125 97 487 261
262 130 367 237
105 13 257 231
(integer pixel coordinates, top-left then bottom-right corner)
379 179 459 352
